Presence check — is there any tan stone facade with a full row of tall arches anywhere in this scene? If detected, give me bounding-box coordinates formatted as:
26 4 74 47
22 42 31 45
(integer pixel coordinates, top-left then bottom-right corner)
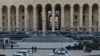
0 0 100 32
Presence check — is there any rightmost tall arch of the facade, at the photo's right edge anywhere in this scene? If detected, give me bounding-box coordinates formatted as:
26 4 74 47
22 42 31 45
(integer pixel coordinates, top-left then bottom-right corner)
92 4 99 31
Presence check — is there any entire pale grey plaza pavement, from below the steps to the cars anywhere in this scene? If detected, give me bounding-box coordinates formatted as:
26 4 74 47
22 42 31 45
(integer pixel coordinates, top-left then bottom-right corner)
0 42 100 56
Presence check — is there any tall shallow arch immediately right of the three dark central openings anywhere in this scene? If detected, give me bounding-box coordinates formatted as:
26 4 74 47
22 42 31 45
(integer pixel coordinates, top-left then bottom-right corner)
64 4 70 31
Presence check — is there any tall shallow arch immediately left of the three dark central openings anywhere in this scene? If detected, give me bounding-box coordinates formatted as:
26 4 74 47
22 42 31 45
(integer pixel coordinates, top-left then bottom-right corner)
27 5 34 31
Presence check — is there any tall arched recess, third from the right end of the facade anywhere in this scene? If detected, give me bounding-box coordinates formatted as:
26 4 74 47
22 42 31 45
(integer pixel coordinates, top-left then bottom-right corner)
73 4 81 31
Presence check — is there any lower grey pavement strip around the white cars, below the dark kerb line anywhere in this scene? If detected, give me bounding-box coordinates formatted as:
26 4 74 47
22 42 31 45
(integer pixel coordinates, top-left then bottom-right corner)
0 49 100 56
